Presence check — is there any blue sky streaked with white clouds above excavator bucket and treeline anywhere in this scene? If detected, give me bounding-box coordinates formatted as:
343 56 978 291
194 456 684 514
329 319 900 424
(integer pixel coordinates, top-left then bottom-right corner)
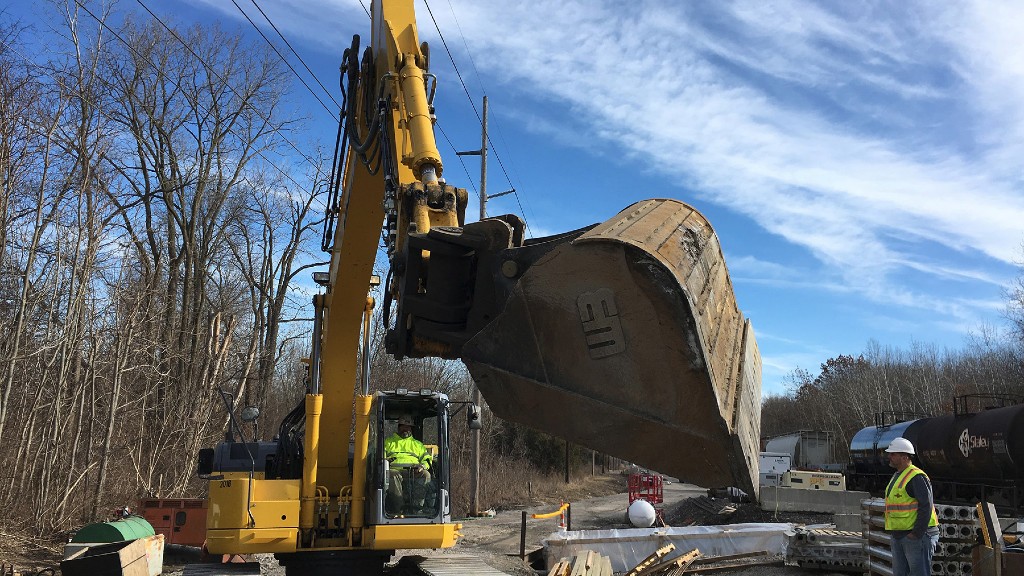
12 0 1024 393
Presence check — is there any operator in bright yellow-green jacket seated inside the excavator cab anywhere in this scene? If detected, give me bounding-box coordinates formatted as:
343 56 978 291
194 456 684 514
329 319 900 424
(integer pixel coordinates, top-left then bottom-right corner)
384 414 433 515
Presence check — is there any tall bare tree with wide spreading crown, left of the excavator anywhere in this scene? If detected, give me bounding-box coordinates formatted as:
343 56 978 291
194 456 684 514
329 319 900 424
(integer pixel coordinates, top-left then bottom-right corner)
93 14 290 489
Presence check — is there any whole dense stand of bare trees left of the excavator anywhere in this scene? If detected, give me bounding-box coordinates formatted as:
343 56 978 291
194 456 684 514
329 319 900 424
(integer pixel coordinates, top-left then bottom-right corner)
0 2 319 531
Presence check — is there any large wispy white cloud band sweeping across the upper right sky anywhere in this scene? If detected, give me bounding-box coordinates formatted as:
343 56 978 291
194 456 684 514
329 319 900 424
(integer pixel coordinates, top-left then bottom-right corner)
417 2 1024 317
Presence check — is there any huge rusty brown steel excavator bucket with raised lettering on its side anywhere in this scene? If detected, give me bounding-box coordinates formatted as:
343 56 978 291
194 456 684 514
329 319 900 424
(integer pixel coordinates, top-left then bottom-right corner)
461 200 761 496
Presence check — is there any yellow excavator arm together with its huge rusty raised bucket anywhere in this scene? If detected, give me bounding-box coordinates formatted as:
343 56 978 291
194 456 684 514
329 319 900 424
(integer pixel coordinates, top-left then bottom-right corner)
324 0 761 494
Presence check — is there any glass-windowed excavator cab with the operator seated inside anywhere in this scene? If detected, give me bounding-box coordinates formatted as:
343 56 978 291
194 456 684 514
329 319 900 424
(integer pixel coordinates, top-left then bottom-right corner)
367 388 452 525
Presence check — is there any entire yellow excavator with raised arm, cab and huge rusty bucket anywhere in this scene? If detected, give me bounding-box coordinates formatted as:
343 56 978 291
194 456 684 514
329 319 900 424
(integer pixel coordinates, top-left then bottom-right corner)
200 0 761 574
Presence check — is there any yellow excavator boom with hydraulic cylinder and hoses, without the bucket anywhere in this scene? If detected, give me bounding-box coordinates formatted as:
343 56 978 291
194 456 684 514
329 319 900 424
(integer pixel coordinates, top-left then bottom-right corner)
317 0 467 498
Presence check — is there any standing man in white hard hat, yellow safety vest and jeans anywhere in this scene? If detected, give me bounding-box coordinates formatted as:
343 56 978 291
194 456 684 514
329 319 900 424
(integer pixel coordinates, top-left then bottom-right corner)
886 438 939 576
